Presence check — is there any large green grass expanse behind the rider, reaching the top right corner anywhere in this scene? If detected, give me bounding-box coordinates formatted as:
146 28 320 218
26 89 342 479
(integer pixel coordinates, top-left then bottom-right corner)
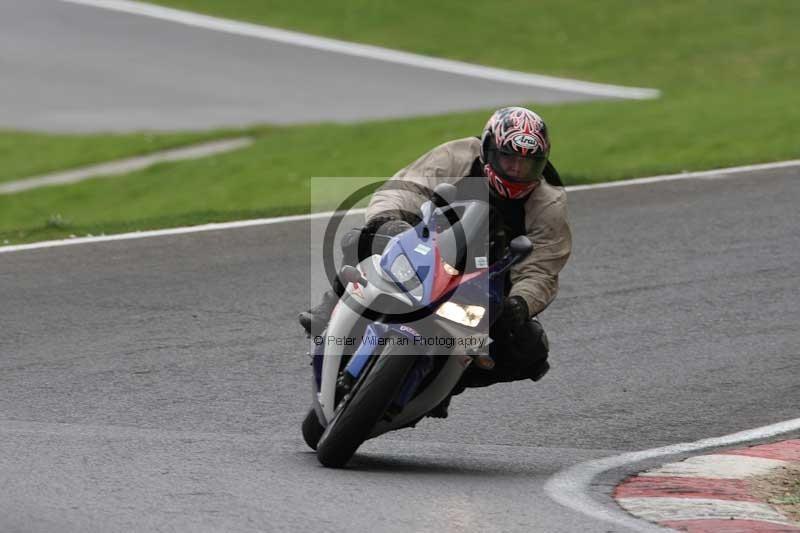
0 0 800 244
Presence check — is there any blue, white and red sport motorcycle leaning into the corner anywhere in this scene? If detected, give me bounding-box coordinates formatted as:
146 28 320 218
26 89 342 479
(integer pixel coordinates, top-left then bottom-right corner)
302 184 533 467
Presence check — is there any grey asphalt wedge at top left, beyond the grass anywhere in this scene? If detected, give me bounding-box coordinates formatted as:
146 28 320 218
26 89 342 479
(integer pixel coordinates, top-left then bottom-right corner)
0 0 608 132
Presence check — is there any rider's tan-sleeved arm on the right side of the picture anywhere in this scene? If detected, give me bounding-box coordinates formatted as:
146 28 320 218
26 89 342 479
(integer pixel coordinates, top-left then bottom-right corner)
510 185 572 316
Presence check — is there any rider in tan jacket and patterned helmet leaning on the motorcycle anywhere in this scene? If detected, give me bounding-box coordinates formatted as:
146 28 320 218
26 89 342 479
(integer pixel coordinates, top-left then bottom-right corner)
298 107 572 417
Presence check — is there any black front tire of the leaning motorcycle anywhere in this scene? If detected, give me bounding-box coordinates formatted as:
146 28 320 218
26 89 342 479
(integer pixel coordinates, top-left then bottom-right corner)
317 346 417 468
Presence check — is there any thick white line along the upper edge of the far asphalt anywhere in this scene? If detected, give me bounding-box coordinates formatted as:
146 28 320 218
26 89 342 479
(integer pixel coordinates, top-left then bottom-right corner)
61 0 661 100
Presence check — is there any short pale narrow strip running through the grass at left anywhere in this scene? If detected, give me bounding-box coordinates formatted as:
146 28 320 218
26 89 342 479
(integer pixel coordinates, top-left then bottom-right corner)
0 137 254 194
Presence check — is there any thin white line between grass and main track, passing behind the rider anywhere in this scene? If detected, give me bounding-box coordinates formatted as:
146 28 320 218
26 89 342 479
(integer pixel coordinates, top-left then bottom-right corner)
0 158 800 254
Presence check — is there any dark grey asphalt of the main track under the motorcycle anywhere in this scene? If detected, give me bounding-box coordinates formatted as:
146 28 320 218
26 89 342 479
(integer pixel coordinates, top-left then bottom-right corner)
0 169 800 532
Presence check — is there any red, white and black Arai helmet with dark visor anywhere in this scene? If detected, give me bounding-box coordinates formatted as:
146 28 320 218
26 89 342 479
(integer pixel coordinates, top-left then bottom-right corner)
481 107 550 199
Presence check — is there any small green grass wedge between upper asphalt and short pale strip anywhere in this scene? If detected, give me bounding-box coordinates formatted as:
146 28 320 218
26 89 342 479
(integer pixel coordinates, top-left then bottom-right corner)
0 130 241 183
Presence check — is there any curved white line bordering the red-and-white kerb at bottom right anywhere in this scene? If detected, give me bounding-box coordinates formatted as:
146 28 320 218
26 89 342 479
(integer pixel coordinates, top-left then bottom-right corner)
544 418 800 532
